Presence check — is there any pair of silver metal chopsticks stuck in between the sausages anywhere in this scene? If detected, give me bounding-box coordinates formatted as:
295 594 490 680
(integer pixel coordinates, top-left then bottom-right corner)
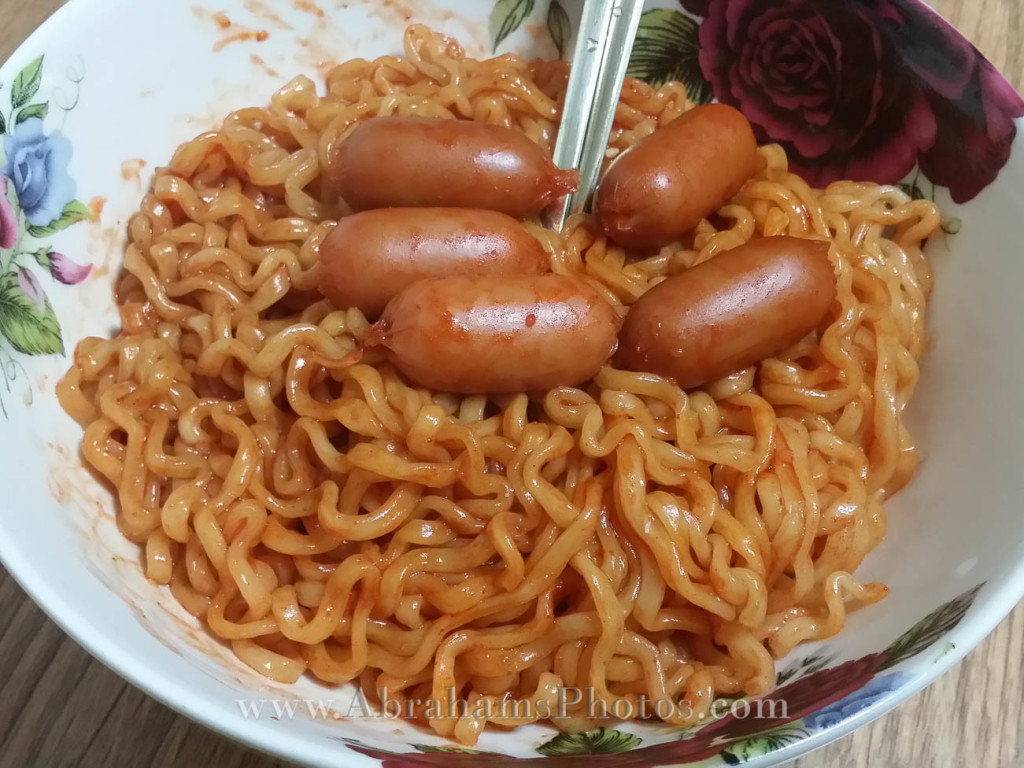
545 0 643 230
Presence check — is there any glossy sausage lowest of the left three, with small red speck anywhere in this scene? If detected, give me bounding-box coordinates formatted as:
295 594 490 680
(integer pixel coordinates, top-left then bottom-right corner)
366 274 620 393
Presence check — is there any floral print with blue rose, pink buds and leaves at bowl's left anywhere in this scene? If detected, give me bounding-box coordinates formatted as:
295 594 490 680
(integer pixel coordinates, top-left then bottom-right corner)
0 56 92 416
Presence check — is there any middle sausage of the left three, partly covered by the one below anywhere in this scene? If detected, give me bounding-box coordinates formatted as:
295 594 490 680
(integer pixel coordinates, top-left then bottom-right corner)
319 208 549 318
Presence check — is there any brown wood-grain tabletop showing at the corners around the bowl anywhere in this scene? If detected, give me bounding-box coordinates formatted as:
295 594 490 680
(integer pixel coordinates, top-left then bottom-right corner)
0 0 1024 768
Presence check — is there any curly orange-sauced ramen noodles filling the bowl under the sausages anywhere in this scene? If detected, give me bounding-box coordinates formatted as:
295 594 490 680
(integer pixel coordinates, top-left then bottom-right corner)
58 27 940 744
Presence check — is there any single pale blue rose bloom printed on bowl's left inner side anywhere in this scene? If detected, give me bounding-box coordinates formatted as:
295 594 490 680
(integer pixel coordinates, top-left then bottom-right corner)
3 118 75 226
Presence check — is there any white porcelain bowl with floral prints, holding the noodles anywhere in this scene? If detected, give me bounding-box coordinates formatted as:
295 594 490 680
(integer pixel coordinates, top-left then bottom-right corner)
0 0 1024 768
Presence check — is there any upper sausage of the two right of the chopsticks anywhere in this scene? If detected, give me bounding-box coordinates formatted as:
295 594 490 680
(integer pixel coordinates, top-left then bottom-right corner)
594 104 758 249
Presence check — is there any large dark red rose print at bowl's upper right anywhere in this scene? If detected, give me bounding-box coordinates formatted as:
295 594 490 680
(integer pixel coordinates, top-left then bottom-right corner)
683 0 1024 203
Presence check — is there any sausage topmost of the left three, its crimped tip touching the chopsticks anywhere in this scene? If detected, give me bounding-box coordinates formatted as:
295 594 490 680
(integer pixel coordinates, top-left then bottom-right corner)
329 117 580 218
